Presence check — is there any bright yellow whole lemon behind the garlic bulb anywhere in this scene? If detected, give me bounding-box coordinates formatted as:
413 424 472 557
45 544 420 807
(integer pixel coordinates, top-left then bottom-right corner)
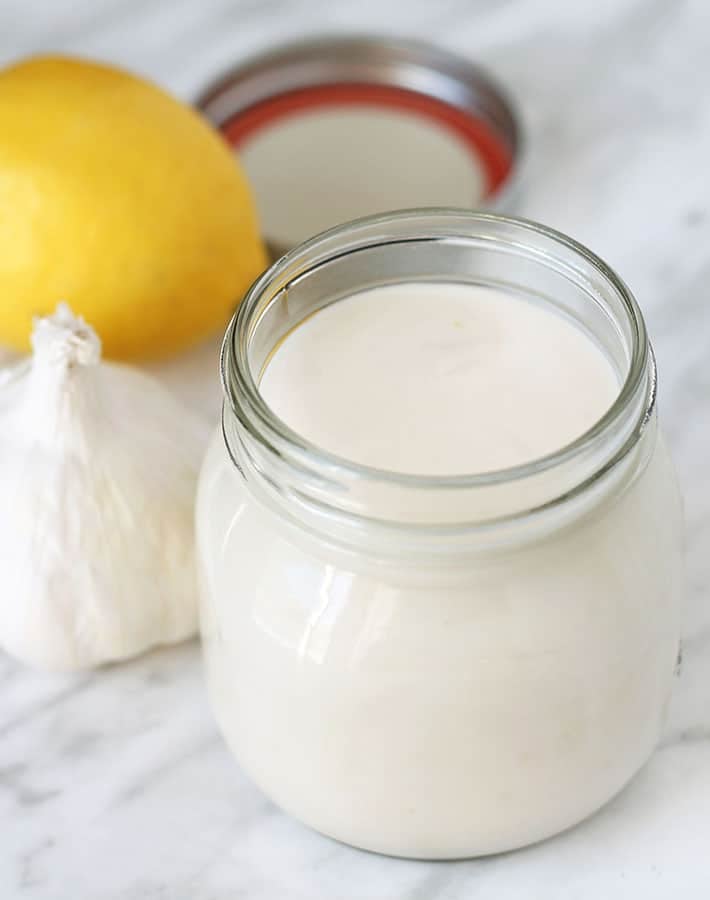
0 57 266 358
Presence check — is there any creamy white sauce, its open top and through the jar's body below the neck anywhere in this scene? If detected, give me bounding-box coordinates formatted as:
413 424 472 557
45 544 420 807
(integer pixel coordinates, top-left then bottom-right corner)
198 283 682 859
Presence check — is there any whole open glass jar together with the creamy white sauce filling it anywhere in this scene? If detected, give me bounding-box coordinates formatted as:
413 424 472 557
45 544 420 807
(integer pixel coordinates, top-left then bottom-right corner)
197 210 682 859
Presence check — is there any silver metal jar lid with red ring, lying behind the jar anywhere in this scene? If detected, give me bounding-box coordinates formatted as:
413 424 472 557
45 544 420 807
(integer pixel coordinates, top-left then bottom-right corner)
197 37 522 255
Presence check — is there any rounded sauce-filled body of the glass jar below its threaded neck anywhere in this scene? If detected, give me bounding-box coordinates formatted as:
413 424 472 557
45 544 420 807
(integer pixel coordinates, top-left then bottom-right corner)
198 420 682 859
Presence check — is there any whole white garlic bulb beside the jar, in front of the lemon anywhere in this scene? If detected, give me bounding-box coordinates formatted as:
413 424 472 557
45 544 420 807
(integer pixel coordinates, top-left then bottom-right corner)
0 305 205 669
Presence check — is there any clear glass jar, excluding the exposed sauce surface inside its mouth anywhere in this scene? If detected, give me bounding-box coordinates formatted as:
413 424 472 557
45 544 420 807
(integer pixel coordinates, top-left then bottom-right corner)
198 210 682 859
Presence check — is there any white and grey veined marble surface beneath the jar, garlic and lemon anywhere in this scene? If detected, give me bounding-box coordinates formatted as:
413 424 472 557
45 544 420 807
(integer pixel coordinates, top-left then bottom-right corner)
0 0 710 900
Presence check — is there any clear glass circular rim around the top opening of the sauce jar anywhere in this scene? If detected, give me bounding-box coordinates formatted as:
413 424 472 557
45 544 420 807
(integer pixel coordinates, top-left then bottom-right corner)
220 207 656 490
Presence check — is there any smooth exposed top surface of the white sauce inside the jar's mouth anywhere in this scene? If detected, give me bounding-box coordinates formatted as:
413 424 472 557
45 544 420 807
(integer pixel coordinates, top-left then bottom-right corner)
260 283 619 475
